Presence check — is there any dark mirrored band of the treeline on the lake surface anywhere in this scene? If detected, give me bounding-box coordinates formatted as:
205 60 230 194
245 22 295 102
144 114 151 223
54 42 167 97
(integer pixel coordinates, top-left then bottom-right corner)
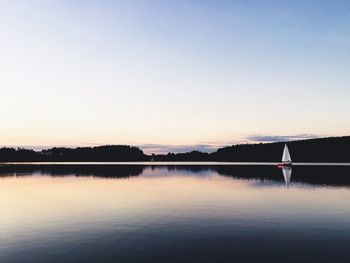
0 165 350 186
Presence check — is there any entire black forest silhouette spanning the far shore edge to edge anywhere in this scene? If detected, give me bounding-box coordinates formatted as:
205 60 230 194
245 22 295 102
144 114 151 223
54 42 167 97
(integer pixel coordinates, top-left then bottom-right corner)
0 136 350 162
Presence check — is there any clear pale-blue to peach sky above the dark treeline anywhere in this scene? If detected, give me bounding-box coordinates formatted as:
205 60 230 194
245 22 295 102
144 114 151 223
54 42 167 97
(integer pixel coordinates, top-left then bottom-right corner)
0 0 350 153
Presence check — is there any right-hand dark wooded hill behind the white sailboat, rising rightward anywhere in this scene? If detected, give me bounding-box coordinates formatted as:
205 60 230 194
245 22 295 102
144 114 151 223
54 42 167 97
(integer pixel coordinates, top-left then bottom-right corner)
152 136 350 162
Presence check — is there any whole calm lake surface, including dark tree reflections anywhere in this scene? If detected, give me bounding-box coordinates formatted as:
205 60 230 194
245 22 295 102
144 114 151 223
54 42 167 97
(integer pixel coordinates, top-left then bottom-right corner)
0 165 350 263
